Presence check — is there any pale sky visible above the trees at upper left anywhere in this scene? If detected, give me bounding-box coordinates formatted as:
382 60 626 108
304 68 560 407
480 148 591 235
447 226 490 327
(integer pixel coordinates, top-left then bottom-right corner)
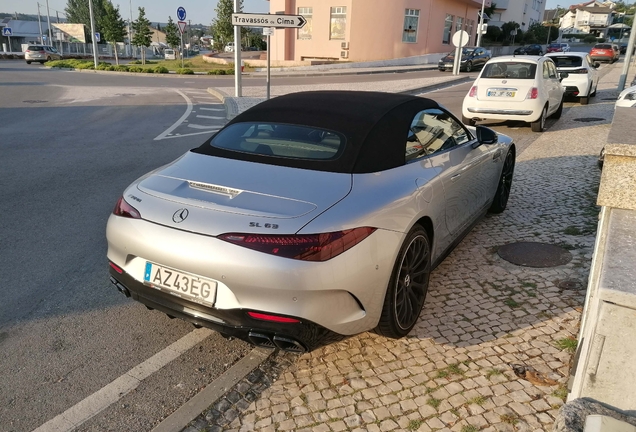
0 0 269 25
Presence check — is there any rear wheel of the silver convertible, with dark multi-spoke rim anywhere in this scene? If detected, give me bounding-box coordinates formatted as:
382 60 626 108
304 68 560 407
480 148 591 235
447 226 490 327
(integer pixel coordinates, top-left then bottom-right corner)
375 225 431 338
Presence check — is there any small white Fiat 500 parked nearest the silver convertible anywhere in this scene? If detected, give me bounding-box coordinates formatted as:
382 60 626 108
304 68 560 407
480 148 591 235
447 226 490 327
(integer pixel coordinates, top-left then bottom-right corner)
462 56 568 132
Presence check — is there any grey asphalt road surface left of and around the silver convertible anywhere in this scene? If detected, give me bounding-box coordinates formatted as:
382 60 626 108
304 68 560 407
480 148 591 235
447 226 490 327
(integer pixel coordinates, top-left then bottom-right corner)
0 61 616 432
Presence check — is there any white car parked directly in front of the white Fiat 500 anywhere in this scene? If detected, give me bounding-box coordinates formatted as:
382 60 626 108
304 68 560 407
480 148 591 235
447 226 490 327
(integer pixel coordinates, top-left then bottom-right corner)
546 52 600 105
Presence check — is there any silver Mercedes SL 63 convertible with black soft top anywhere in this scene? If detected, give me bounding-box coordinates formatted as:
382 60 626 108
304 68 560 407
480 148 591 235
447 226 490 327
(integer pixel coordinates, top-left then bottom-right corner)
106 91 515 352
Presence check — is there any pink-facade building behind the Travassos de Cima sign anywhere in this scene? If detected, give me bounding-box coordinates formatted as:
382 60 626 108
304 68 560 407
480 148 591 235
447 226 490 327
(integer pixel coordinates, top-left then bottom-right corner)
270 0 482 62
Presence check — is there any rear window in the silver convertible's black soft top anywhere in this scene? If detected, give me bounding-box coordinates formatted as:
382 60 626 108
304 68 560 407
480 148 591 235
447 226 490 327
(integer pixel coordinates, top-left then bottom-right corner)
210 122 345 160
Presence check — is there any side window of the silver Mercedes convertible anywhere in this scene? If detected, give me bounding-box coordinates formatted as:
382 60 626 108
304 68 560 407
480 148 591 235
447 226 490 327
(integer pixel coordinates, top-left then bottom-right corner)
405 108 472 162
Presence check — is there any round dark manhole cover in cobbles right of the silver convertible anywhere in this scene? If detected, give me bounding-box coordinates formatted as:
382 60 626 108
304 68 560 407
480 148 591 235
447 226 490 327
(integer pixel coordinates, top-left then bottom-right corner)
497 242 572 268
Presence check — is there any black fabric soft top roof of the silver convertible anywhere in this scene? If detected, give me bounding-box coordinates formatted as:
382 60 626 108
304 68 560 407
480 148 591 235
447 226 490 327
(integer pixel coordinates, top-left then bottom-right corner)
192 91 439 173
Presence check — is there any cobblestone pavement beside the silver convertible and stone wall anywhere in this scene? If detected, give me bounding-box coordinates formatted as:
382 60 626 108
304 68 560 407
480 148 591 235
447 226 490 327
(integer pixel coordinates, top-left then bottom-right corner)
185 62 620 432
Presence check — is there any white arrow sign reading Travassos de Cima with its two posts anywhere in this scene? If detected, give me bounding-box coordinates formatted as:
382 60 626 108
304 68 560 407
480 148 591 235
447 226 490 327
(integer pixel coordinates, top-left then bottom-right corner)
232 13 306 99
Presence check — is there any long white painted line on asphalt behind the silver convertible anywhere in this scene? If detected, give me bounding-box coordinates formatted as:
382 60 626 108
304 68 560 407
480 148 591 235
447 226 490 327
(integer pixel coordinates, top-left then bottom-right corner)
33 328 212 432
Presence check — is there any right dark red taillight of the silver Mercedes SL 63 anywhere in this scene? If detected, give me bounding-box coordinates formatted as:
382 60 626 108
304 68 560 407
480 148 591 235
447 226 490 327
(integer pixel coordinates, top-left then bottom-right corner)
218 227 376 261
